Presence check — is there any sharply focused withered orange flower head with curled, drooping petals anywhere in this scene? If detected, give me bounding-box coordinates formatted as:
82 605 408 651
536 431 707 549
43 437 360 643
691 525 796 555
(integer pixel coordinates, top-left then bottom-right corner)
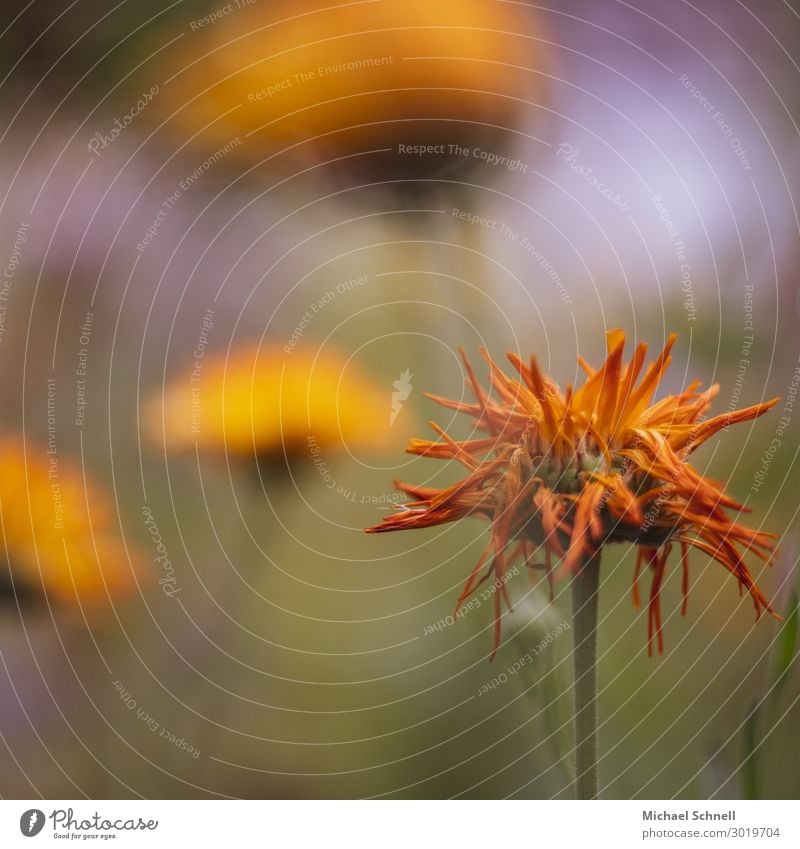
367 330 779 656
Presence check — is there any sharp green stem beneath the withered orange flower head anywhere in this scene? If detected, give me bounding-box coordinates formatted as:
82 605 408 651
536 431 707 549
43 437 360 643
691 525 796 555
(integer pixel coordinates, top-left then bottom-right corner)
572 550 600 799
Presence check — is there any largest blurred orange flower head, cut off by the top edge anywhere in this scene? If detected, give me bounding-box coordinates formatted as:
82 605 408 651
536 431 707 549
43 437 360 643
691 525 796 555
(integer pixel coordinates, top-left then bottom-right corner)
151 0 545 176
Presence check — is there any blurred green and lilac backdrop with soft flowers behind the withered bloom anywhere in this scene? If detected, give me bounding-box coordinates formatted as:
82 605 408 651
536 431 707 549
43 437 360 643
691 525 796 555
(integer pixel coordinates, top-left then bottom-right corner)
0 0 800 798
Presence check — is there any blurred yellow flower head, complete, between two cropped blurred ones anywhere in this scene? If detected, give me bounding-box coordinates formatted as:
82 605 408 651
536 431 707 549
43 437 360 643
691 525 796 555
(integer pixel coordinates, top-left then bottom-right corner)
145 345 392 458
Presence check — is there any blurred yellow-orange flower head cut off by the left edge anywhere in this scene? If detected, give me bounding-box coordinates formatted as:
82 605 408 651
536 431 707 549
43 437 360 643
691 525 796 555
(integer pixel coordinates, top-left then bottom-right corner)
0 437 136 606
